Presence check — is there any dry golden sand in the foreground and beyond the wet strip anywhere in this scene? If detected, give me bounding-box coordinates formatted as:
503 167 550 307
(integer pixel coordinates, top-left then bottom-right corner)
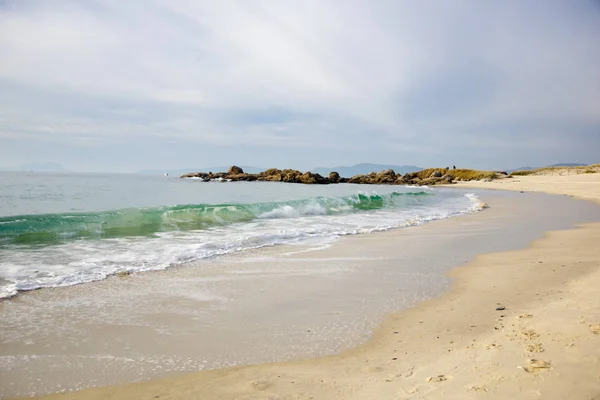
22 174 600 400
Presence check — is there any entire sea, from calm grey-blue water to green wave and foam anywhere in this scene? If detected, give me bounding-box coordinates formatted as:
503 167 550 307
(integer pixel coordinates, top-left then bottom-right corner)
0 173 478 297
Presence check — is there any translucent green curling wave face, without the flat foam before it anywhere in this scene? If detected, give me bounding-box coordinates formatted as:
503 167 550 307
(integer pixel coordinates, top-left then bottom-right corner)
0 191 433 245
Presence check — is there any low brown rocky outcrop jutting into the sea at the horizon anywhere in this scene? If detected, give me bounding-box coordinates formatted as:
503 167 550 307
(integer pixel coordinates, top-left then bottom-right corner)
181 165 454 185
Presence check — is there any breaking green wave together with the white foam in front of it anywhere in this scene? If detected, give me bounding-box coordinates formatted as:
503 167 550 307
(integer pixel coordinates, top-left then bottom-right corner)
0 187 483 298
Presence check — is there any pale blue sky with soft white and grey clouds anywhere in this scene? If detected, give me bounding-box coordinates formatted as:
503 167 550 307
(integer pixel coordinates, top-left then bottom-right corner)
0 0 600 172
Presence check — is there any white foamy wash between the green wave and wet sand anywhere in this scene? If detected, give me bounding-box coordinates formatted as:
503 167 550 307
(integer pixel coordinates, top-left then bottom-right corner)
0 187 483 298
